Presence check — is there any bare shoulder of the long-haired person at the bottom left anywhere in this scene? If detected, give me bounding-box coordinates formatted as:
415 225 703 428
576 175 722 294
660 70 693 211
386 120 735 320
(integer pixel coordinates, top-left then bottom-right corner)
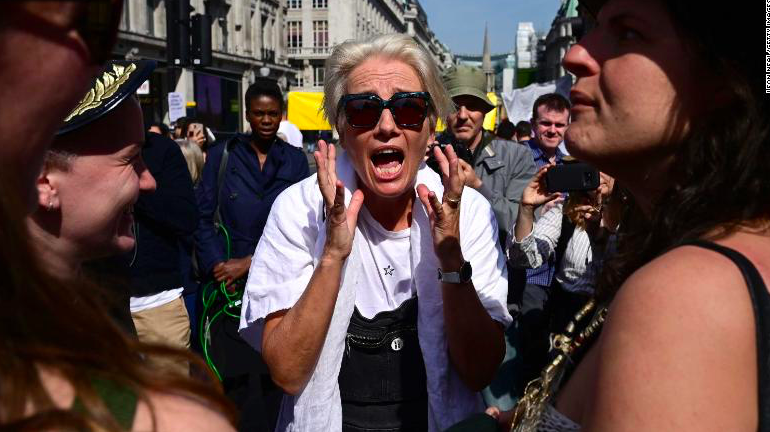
133 393 235 432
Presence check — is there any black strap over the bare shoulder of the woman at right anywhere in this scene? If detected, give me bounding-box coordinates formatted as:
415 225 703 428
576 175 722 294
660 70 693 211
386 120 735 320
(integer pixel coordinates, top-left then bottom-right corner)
681 240 770 432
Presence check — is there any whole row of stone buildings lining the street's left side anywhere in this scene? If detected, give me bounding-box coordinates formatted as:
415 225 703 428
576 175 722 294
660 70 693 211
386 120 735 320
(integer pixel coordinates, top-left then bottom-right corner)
113 0 453 133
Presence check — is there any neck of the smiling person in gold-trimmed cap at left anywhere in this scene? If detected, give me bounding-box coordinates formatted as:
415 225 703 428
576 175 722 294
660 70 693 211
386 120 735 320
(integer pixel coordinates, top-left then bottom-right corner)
27 211 83 279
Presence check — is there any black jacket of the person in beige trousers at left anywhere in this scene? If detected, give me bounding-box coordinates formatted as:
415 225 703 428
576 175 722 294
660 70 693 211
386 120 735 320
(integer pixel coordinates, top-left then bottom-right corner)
131 133 198 297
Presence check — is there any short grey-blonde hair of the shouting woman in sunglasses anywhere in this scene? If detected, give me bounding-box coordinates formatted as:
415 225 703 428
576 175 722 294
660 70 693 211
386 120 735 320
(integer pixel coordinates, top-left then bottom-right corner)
323 34 454 131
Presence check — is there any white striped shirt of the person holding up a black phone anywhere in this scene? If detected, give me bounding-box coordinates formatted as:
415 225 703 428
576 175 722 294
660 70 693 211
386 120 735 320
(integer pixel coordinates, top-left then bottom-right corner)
507 204 612 294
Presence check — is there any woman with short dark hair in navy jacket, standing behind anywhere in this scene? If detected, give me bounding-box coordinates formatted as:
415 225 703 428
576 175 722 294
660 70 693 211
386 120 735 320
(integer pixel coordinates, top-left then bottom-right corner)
196 79 310 430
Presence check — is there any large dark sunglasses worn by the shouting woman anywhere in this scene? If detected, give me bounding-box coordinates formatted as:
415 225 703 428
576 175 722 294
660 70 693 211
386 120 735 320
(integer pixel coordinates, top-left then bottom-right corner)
339 92 431 128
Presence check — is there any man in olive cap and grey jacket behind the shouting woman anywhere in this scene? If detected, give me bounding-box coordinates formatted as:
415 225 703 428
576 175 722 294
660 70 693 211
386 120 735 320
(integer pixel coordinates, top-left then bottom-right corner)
443 66 535 244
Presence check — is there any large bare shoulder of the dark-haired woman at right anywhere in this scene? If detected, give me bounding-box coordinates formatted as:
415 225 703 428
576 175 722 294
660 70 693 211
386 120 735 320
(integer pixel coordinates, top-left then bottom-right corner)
583 240 757 431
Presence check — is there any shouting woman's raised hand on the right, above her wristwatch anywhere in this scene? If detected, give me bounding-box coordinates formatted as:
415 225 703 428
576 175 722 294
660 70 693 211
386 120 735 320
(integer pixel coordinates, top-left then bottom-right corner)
417 145 465 271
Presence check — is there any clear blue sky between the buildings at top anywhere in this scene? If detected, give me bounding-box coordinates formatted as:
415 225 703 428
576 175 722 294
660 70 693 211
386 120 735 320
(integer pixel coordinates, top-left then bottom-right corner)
420 0 561 55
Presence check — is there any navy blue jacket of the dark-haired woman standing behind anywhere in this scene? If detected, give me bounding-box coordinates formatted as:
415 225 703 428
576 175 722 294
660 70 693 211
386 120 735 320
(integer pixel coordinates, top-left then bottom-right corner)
195 134 310 275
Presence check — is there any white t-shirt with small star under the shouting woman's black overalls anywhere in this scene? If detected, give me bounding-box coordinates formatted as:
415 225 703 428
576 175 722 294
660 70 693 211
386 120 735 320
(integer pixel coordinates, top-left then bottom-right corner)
356 206 417 318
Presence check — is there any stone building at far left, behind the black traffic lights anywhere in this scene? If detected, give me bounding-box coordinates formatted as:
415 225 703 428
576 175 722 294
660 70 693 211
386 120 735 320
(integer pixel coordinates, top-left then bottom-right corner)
113 0 296 133
